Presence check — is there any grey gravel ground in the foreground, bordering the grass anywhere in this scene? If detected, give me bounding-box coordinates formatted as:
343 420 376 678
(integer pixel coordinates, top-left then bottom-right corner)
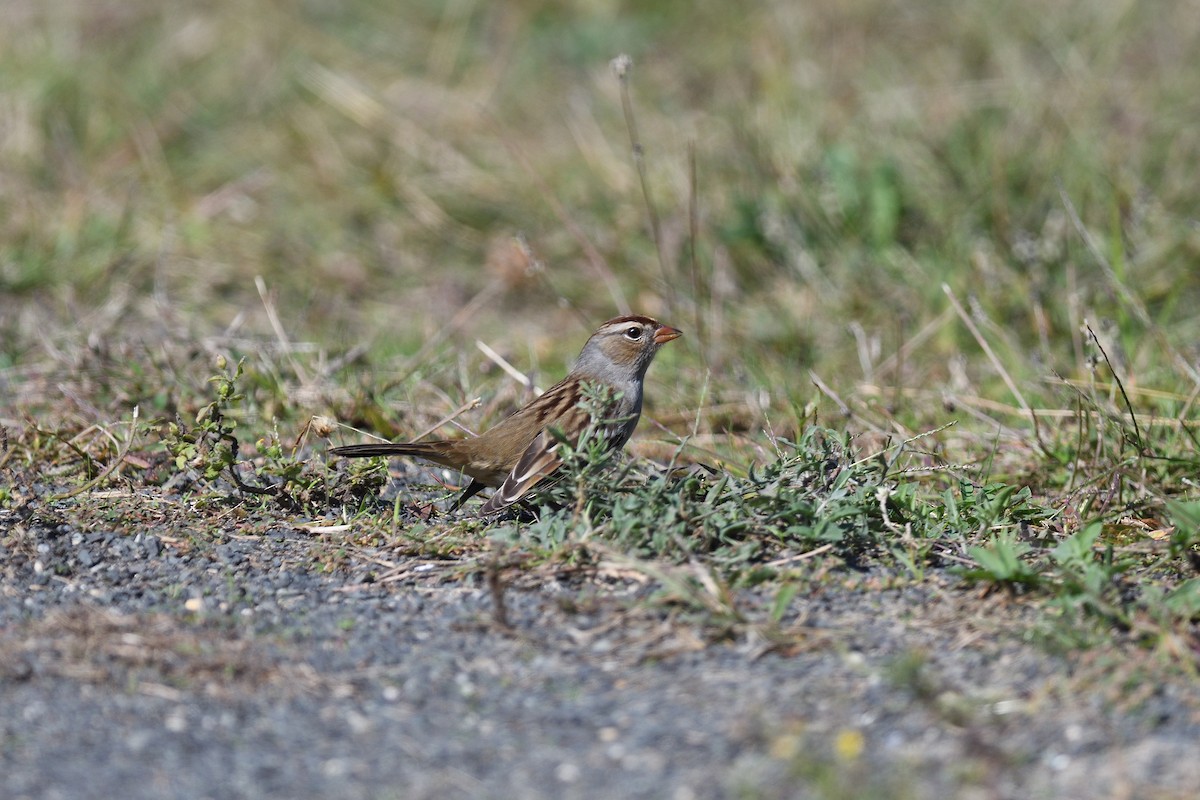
0 511 1200 799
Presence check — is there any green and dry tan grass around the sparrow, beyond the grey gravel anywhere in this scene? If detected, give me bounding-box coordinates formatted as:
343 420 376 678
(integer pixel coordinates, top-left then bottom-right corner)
0 0 1200 690
